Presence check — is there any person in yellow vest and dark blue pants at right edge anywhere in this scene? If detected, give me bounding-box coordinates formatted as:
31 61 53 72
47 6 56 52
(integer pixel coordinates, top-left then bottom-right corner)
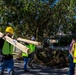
68 39 76 75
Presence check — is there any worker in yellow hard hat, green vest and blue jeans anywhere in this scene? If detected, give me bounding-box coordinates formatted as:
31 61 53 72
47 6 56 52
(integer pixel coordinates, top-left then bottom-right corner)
0 27 15 75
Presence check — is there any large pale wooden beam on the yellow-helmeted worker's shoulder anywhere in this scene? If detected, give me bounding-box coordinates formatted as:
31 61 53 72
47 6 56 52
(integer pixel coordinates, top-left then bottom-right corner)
0 32 29 53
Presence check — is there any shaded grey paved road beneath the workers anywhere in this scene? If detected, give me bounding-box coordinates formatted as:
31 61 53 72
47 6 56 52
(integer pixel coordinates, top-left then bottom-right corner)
4 60 68 75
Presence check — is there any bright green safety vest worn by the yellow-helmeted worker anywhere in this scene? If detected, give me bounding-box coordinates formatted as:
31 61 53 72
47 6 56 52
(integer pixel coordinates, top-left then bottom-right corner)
2 41 13 55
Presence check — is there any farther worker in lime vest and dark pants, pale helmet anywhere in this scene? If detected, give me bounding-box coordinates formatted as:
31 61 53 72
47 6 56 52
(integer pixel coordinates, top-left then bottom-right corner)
28 37 36 68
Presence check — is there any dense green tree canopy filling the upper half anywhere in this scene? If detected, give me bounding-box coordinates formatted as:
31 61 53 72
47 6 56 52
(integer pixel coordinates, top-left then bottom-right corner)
0 0 76 41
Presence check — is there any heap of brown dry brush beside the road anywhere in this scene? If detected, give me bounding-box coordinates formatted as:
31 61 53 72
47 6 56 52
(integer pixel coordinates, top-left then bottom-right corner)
37 49 69 68
